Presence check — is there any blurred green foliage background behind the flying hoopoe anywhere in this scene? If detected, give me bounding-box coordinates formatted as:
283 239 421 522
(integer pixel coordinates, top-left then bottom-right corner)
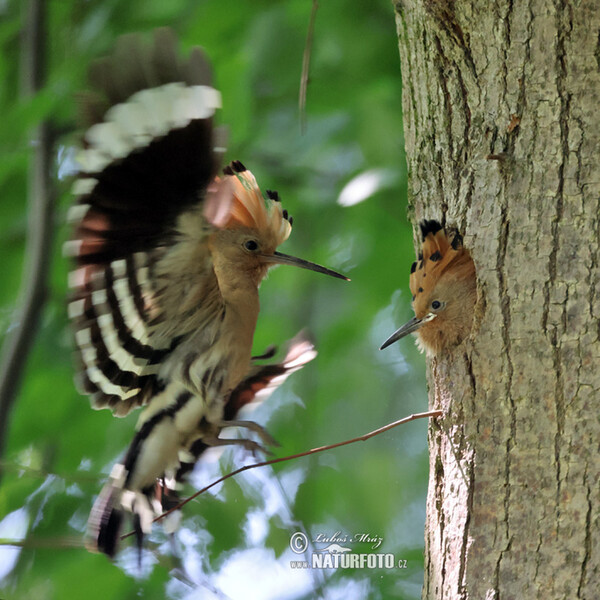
0 0 428 600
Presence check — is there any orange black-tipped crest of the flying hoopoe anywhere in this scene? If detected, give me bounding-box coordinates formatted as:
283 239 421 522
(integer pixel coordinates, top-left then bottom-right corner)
204 160 293 246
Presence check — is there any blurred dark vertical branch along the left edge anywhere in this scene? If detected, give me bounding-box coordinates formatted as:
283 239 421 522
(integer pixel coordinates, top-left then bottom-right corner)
0 0 54 477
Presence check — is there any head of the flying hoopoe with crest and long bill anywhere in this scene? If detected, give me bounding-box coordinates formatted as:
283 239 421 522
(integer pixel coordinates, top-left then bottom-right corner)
204 161 348 285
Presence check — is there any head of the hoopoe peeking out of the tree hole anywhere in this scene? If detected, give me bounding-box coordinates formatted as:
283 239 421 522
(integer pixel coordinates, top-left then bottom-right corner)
381 221 477 354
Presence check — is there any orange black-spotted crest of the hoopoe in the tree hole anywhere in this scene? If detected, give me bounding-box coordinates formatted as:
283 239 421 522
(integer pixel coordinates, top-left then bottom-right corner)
409 220 471 316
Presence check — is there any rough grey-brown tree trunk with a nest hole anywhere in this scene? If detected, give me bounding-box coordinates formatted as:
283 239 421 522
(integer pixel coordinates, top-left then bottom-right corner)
395 0 600 600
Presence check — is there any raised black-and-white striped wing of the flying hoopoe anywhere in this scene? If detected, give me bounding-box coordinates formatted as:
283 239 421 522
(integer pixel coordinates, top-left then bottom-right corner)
65 29 220 415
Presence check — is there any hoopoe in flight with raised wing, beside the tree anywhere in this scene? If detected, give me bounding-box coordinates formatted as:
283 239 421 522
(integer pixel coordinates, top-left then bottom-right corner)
65 29 347 555
